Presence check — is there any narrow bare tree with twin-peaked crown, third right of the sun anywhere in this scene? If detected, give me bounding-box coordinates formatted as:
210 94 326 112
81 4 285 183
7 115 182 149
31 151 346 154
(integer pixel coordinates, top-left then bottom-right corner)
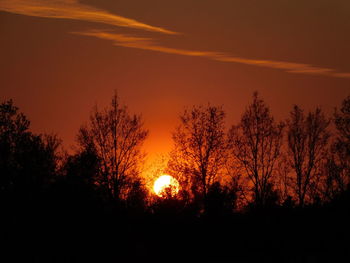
287 106 329 207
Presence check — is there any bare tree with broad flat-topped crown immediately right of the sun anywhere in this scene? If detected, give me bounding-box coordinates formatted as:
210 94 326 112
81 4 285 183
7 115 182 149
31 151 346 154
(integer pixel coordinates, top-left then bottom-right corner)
168 105 226 206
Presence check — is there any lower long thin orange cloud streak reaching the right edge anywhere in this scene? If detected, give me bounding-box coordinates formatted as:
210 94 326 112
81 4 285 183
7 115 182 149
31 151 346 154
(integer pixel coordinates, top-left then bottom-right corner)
73 30 350 78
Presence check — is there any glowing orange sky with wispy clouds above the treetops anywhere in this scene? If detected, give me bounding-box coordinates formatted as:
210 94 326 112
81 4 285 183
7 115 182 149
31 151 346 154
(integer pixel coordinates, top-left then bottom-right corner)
0 0 350 163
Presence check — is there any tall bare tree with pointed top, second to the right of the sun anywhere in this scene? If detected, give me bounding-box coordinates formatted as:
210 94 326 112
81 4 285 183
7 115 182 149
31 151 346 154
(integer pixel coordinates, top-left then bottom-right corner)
228 93 284 206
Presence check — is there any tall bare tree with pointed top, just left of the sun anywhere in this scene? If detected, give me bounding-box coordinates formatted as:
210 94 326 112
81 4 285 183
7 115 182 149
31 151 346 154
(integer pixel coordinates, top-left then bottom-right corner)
78 95 148 200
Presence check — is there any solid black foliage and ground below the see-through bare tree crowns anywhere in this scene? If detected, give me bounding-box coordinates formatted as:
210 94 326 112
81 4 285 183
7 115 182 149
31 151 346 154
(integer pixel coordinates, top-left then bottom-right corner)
0 96 350 262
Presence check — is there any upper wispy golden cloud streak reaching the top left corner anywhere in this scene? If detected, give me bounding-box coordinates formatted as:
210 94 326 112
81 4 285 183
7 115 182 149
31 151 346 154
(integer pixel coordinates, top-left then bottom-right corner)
0 0 176 34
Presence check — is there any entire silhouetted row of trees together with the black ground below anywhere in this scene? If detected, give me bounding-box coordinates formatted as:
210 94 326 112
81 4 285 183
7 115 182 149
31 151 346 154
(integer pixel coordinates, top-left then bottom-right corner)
0 93 350 262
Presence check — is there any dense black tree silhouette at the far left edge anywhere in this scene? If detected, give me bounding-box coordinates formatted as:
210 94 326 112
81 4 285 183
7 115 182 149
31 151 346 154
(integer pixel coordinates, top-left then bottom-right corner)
0 100 61 200
